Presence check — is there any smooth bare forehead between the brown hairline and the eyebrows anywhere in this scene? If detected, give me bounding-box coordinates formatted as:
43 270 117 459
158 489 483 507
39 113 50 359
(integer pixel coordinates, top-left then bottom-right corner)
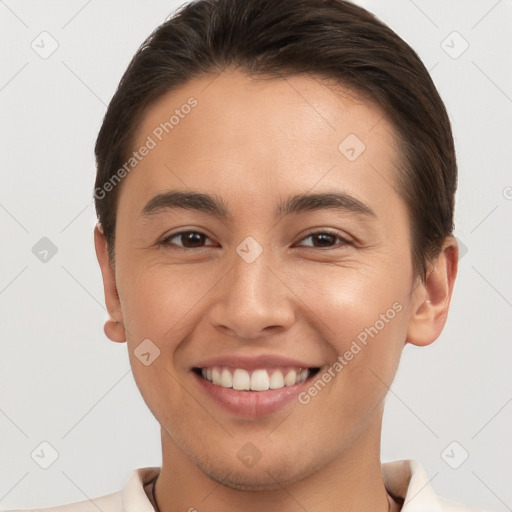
123 71 397 212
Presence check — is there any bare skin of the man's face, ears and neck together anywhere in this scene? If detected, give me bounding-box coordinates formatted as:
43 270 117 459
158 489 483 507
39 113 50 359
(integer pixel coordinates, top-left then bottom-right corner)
95 71 457 512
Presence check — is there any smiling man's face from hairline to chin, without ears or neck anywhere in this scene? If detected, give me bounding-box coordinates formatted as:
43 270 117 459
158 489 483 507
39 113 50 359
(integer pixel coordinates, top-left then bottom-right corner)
99 72 424 489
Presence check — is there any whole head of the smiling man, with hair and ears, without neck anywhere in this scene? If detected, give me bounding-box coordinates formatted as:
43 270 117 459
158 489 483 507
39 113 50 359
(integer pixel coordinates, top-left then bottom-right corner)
95 0 457 489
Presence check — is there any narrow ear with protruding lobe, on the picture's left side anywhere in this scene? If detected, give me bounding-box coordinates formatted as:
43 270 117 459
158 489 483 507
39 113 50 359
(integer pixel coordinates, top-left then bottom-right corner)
94 224 126 343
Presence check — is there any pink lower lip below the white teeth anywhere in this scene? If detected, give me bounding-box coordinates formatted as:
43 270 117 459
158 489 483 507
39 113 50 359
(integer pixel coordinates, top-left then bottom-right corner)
192 372 314 418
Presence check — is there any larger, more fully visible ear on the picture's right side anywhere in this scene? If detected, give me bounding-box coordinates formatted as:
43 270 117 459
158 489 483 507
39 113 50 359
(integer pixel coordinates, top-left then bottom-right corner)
407 236 459 346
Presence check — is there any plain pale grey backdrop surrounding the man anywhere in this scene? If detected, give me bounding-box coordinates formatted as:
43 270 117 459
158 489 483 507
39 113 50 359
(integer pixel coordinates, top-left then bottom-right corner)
0 0 512 511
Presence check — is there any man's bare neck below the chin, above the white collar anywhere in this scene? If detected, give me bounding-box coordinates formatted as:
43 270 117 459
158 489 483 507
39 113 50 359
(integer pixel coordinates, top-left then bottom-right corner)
155 410 395 512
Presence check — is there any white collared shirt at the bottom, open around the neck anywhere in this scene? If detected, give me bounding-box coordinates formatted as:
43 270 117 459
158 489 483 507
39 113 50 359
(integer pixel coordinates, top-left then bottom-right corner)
0 460 477 512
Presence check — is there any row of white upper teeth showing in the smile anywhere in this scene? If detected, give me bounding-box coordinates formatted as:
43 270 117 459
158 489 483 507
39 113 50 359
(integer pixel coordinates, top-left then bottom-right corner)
201 366 310 391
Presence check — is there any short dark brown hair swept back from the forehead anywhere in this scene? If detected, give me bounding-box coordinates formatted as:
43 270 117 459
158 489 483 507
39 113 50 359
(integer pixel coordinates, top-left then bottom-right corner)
94 0 457 279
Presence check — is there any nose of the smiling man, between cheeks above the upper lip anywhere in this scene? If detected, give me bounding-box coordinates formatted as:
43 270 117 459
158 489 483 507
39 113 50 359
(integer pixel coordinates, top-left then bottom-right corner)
210 244 295 340
